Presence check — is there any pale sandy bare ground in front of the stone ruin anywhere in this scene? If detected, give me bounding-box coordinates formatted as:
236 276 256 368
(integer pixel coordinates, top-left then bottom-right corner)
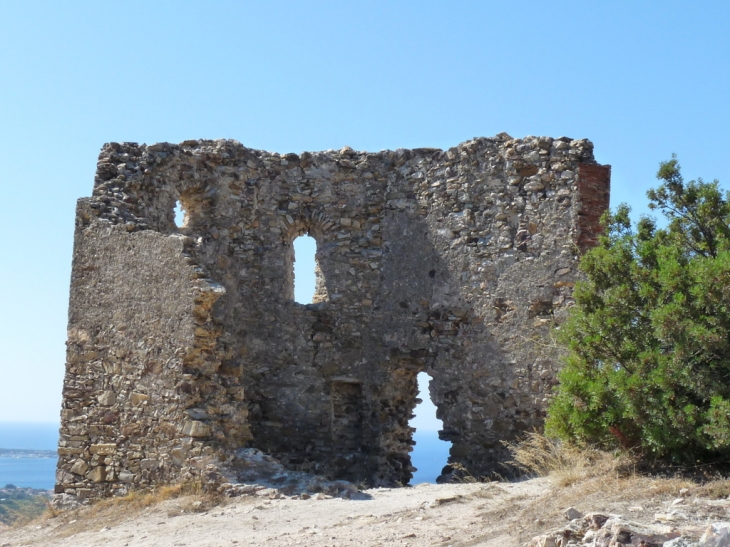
0 479 549 547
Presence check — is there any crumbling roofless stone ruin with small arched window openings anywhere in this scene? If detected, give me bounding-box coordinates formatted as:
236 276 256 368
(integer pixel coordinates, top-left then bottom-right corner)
56 133 610 499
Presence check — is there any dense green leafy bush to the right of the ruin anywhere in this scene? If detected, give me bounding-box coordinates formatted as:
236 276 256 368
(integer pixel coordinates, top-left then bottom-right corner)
546 158 730 462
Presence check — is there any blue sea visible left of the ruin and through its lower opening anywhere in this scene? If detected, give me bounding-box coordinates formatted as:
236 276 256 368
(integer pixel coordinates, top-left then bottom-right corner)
0 422 451 490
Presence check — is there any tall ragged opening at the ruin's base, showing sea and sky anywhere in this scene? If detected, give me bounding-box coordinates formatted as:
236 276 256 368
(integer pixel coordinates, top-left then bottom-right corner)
408 372 451 485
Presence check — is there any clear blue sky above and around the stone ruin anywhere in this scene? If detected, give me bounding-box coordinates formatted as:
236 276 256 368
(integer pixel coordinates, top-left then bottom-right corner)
0 0 730 421
